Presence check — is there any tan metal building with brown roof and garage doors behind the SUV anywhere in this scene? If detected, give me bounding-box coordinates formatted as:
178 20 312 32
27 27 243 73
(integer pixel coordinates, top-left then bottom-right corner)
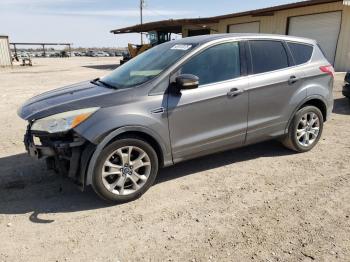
111 0 350 71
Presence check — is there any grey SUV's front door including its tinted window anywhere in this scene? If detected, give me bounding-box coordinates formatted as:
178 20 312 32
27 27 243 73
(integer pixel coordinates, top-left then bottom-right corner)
168 42 248 162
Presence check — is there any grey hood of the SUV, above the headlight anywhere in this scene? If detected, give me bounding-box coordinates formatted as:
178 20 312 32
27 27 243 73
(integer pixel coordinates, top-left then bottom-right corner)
18 81 117 120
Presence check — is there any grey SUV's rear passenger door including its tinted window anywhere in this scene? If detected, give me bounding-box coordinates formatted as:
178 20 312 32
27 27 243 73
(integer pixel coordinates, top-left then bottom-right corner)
247 40 306 143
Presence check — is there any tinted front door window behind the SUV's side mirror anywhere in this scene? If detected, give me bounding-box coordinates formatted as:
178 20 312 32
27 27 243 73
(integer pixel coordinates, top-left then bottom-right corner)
180 42 241 85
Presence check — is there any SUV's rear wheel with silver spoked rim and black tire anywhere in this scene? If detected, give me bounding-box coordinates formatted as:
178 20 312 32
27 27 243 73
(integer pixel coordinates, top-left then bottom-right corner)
282 106 323 153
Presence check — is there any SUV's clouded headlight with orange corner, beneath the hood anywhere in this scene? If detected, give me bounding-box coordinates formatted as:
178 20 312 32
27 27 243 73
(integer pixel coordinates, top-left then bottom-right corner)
31 107 99 133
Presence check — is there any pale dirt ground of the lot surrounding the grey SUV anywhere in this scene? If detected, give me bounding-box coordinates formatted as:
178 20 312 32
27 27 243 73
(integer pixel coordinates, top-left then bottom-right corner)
0 58 350 262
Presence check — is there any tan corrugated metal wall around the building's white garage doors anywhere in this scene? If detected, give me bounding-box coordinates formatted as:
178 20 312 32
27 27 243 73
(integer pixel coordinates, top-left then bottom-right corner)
183 1 350 71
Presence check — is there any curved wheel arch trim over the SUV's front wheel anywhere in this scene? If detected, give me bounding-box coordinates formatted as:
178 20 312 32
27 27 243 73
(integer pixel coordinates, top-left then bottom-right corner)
85 126 173 186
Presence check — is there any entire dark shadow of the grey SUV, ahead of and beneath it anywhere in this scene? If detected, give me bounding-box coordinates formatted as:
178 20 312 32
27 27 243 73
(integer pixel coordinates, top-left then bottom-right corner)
0 141 292 223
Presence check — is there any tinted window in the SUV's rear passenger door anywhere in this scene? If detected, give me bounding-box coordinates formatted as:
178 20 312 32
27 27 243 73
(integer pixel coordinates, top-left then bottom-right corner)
249 40 289 74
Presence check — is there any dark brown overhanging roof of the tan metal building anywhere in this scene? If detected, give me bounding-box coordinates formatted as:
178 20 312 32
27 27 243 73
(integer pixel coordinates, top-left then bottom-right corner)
111 0 342 34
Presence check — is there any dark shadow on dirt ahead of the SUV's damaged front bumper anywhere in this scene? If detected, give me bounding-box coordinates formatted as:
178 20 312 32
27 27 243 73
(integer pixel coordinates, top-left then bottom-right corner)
0 154 109 223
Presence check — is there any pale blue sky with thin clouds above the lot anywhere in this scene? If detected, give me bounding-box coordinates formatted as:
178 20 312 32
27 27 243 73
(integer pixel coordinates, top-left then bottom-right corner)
0 0 304 47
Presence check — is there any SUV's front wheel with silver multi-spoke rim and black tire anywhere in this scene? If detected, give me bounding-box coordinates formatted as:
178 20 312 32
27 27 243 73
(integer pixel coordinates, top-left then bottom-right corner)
92 138 158 204
